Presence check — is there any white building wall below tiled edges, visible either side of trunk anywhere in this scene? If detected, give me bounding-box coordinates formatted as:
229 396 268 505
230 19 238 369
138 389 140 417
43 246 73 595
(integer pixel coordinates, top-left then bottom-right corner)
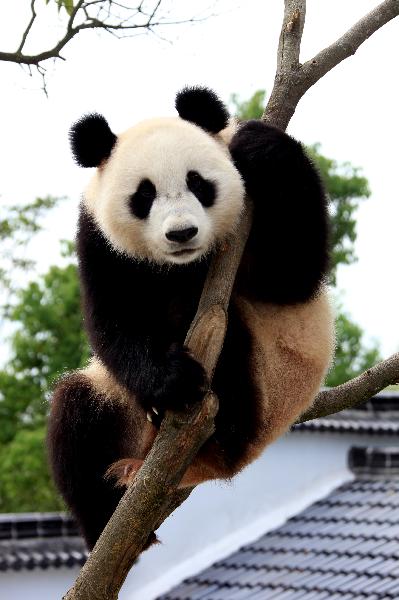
0 433 390 600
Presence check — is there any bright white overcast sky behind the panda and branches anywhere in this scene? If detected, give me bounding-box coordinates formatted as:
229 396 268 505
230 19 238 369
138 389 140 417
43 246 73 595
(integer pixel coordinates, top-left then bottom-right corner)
0 0 399 356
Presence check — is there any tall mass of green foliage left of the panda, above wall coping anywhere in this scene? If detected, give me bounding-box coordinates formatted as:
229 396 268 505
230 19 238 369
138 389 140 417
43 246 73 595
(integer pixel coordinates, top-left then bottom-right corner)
0 251 89 512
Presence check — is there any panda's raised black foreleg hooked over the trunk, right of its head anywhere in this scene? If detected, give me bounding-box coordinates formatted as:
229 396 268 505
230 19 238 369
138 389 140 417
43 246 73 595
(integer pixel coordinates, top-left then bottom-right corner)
230 121 329 304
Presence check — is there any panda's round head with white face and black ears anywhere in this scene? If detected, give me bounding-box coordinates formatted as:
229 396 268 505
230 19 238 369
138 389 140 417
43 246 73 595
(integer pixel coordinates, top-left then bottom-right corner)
70 88 244 264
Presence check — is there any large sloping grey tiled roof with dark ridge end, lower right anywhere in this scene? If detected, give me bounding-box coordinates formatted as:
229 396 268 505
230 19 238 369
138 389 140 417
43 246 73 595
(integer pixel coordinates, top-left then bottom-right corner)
158 448 399 600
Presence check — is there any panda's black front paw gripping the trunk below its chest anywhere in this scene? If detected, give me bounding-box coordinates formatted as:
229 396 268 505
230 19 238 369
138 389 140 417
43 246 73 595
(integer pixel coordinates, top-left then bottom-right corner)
148 344 209 416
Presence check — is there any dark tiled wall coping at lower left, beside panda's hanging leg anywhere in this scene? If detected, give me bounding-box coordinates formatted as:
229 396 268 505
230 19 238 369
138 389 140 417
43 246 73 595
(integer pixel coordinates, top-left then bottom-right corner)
0 513 87 571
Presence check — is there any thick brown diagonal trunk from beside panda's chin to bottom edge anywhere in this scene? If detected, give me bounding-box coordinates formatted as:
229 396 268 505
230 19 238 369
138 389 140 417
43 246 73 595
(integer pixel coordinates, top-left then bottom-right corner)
64 203 255 600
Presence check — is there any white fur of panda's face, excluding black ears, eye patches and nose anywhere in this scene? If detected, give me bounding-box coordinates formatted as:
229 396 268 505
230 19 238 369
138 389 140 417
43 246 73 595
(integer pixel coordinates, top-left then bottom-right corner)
84 118 244 263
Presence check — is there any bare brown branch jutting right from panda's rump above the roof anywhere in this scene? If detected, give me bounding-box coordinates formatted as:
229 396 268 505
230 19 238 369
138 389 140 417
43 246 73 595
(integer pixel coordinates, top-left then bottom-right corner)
298 353 399 423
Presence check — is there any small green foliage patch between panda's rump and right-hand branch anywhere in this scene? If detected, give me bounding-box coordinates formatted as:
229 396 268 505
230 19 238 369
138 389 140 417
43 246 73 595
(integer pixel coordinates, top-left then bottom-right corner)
326 312 381 386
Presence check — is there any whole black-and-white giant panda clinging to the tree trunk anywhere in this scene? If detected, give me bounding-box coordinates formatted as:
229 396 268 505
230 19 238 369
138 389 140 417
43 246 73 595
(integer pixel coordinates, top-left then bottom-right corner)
48 87 334 548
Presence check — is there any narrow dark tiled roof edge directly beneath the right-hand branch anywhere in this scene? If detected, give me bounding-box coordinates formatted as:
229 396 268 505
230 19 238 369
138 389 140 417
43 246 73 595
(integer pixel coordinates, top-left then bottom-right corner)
293 392 399 436
